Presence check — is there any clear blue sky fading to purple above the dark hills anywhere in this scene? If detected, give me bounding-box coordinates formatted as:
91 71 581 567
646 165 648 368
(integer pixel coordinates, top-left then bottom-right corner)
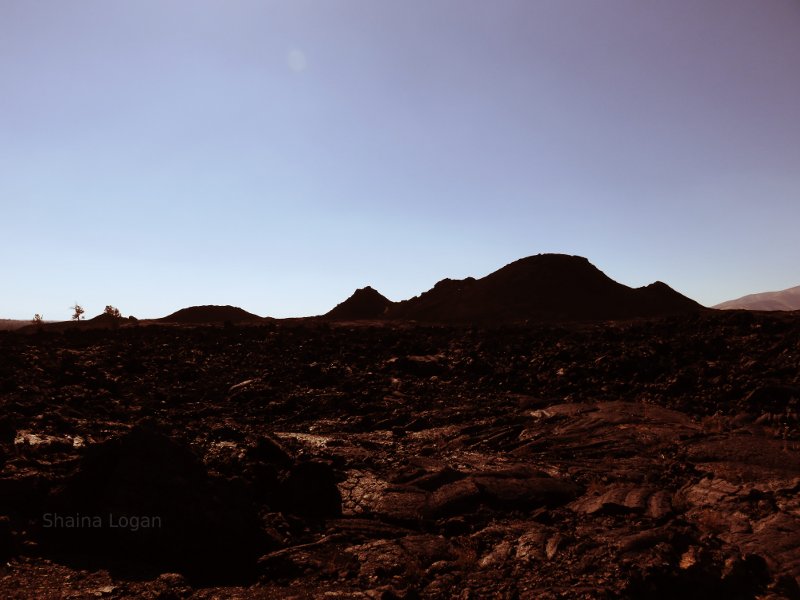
0 0 800 319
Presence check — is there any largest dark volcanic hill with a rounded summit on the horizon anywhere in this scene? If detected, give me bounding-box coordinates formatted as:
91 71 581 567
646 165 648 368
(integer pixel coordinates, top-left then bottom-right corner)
387 254 703 323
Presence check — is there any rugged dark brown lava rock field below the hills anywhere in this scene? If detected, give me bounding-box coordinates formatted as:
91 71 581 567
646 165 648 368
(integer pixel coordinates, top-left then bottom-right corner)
0 312 800 599
